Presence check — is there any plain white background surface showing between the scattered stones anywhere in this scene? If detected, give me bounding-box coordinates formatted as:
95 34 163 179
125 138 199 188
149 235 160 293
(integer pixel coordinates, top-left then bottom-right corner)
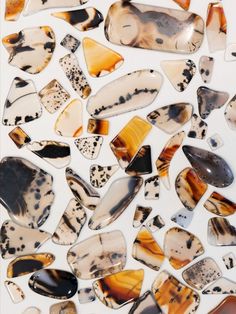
0 0 236 314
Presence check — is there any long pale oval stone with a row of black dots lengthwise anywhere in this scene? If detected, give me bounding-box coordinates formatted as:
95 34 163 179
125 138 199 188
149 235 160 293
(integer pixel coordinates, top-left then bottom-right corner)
87 69 163 118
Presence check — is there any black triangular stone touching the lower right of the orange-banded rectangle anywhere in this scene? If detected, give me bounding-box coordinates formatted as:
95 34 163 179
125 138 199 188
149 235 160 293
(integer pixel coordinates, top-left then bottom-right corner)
125 145 152 176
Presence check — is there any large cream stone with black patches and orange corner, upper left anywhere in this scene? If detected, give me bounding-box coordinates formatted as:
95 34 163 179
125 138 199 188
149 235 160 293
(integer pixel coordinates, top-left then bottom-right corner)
2 26 56 74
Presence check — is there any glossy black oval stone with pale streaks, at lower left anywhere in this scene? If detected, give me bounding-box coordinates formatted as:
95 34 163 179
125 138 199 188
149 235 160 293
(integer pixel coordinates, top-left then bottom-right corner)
28 269 78 300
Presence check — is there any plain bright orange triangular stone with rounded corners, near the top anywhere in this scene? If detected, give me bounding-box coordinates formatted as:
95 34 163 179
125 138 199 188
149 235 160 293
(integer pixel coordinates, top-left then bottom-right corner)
83 37 124 77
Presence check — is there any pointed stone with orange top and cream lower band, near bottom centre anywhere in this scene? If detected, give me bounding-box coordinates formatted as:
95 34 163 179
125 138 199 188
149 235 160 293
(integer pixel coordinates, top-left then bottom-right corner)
132 227 165 270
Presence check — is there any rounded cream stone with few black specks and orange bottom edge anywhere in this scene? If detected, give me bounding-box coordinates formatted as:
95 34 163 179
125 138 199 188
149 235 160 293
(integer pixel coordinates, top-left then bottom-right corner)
164 227 204 269
